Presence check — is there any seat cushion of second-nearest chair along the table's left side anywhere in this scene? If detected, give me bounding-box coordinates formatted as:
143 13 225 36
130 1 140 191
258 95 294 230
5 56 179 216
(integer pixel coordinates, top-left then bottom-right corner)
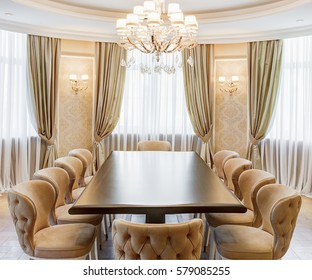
55 204 103 226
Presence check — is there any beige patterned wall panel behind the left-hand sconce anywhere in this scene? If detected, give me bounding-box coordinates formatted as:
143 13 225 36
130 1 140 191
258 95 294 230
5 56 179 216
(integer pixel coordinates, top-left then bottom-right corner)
58 56 94 156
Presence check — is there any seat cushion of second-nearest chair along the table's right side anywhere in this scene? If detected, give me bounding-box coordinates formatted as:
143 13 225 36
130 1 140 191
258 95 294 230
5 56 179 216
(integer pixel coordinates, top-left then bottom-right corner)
205 209 254 228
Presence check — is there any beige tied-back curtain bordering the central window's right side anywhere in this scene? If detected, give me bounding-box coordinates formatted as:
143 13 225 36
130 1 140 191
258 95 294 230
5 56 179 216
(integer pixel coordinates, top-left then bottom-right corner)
183 45 214 167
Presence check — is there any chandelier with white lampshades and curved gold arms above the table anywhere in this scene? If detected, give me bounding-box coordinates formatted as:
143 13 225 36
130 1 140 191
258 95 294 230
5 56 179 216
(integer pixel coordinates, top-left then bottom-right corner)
116 0 198 62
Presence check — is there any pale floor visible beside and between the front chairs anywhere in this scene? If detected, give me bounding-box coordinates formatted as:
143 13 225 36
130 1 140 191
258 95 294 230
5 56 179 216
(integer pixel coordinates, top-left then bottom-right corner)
0 194 312 260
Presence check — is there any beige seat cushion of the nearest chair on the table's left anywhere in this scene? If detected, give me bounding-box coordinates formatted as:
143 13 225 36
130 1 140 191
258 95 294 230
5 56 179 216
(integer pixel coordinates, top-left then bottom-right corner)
34 224 96 259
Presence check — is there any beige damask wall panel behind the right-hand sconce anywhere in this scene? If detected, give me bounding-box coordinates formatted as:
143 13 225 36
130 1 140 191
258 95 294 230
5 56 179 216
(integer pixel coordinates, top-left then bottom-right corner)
214 59 247 157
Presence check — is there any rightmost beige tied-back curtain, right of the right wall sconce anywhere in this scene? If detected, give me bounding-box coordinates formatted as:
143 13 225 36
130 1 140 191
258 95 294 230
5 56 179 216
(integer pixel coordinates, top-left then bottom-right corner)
247 40 283 169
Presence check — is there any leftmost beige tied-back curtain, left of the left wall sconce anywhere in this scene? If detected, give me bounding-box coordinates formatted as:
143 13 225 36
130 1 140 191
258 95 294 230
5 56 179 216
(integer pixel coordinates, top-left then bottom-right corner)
27 35 61 167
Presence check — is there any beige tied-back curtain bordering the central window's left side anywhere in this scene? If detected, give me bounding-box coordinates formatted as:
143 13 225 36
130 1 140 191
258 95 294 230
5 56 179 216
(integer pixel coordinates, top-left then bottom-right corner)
93 42 126 172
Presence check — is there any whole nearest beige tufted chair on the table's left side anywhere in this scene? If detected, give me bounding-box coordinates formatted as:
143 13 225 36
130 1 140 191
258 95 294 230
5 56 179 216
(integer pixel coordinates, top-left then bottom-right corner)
8 180 96 259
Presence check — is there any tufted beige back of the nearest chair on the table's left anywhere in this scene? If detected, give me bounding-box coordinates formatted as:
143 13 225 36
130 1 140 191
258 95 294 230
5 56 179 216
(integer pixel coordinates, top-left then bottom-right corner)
8 180 56 256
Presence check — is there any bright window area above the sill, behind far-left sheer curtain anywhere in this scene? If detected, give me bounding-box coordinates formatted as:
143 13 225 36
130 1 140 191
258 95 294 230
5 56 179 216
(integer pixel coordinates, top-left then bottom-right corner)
0 30 37 139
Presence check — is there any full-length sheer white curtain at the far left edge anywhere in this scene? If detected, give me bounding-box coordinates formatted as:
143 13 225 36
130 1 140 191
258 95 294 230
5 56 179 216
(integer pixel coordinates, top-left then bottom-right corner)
0 30 40 192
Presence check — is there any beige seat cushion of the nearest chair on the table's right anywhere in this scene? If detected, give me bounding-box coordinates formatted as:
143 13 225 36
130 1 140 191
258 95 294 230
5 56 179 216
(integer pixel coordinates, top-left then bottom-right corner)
214 225 274 260
